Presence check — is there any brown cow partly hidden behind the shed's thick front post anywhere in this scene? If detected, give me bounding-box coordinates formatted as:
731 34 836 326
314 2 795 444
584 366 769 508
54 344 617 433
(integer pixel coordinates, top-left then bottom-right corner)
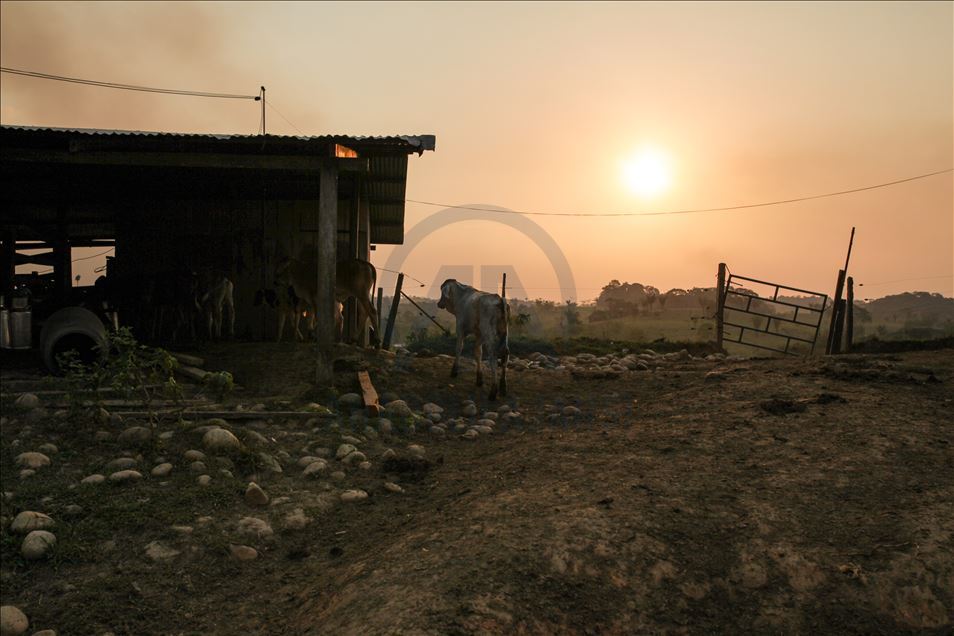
275 258 378 346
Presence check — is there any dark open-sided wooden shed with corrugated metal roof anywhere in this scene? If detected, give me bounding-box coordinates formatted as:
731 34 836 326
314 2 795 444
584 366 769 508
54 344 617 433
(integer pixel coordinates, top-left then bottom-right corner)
0 126 435 380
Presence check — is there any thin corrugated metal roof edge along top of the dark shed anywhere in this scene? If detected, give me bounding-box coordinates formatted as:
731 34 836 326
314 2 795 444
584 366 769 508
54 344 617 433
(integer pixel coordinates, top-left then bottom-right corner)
0 124 437 152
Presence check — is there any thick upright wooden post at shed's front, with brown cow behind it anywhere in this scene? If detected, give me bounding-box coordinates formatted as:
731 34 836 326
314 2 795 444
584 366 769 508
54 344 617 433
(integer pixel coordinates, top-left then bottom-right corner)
315 165 338 388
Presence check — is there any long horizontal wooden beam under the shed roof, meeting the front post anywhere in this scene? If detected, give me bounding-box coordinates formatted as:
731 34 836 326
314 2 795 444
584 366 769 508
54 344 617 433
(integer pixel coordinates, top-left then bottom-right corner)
0 148 370 172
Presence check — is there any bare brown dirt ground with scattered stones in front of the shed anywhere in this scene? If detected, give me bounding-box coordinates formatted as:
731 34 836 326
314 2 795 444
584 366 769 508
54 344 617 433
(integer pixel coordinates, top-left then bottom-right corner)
0 343 954 635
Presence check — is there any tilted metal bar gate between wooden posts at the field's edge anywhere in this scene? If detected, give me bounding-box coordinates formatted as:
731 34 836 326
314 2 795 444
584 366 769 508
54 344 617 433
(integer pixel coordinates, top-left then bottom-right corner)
719 274 828 355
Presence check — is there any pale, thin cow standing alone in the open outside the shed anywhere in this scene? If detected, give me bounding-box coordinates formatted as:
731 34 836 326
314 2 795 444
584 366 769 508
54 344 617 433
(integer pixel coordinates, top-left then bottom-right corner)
437 278 510 400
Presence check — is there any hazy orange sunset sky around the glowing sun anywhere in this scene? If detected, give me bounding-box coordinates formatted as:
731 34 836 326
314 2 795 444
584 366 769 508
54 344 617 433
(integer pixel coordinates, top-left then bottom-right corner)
0 2 954 300
